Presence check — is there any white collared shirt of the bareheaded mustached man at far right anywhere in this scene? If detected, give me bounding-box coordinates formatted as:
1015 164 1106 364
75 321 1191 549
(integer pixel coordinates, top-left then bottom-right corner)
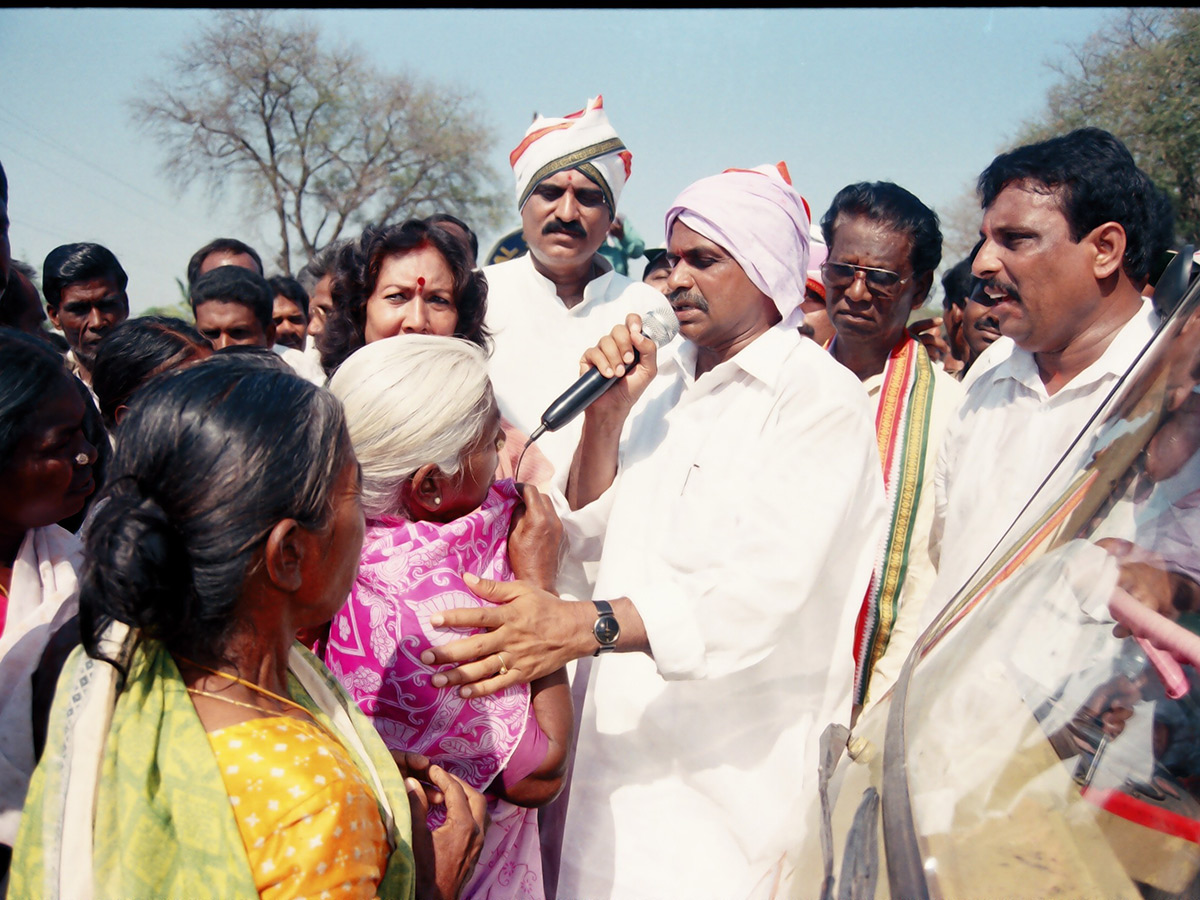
922 300 1158 628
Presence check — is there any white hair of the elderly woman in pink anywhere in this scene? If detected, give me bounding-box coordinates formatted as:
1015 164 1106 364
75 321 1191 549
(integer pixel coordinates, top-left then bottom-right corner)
329 335 496 518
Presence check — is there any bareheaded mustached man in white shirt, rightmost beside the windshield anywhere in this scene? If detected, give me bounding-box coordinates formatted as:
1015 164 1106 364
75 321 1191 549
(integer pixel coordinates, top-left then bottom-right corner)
923 128 1171 622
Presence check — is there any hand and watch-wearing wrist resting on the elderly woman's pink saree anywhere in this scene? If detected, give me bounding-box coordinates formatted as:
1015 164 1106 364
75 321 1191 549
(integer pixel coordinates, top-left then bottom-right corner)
421 575 649 697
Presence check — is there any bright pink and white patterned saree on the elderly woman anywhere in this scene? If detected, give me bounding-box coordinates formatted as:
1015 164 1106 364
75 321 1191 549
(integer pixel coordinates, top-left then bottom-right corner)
325 480 544 900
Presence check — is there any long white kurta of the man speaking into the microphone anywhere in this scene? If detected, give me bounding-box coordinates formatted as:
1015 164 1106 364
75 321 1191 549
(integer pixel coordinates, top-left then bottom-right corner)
558 326 884 900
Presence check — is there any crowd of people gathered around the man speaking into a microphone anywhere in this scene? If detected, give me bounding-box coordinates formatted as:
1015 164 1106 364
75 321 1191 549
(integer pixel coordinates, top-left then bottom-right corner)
0 91 1172 900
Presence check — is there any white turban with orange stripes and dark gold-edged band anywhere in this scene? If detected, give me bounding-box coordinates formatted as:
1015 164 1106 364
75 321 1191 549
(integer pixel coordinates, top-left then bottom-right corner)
509 96 634 216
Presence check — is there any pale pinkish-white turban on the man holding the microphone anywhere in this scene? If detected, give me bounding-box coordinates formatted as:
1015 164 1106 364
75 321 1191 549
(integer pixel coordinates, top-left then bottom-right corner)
666 163 812 326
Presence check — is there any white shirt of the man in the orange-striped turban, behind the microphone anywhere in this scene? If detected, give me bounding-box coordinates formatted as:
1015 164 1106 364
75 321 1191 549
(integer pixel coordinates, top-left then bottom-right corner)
484 253 662 484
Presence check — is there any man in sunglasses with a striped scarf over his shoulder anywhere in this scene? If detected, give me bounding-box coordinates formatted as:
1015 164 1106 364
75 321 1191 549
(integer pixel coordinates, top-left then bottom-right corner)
821 181 962 720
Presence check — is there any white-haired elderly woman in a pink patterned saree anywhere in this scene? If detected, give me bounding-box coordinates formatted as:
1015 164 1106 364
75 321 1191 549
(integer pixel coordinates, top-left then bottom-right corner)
324 335 572 898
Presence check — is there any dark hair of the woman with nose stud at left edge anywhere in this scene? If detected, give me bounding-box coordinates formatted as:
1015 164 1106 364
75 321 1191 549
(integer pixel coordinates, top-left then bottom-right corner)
0 328 71 472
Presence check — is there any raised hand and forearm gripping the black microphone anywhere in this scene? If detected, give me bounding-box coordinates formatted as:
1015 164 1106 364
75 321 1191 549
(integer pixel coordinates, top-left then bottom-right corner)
566 313 659 509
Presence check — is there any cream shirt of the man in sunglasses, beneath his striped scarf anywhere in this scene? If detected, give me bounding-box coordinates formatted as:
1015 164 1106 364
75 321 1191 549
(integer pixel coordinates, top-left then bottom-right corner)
863 355 964 704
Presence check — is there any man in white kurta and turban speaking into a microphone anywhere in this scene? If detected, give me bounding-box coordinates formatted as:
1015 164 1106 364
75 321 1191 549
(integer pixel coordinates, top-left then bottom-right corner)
427 164 884 900
